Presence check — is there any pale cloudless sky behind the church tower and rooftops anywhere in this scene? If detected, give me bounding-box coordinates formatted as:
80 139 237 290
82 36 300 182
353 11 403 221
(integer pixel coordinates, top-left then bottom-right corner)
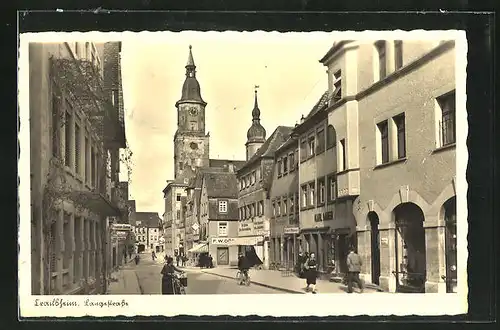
121 32 334 216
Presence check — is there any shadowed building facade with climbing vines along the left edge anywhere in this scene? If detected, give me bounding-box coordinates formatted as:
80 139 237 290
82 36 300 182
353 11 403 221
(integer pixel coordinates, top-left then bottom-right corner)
29 42 125 294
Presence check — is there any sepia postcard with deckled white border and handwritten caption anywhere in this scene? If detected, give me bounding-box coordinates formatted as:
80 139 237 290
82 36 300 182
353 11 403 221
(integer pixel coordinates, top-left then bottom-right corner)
18 30 468 317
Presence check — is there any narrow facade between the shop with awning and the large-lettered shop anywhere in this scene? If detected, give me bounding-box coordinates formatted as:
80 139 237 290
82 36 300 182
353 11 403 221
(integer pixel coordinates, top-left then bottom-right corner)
269 136 300 269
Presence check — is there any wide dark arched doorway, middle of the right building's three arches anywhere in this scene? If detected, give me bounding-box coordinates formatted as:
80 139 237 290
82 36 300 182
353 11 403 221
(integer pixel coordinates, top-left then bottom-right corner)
394 203 427 293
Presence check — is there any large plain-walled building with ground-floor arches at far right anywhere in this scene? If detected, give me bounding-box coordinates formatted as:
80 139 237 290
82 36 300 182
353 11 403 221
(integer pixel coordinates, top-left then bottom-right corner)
329 40 457 292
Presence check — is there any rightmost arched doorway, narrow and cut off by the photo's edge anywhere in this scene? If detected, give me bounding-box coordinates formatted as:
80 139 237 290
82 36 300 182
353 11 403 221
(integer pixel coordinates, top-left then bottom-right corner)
443 197 457 293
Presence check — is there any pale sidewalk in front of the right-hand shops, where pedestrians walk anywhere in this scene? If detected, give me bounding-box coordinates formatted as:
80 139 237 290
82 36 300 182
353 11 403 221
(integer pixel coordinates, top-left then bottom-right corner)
202 268 379 294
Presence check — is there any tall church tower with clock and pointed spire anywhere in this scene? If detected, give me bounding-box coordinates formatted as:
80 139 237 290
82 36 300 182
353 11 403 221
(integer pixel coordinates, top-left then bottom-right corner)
174 46 209 179
